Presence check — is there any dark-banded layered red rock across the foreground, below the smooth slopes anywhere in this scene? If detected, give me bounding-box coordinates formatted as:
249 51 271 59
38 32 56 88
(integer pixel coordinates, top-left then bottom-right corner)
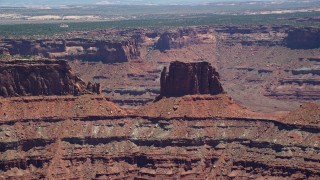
0 112 320 179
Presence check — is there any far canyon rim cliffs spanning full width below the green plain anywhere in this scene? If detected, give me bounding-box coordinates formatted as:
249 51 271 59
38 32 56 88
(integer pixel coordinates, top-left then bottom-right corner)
0 26 319 63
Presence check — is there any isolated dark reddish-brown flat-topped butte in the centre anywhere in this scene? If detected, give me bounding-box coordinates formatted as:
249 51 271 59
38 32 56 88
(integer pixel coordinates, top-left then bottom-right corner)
160 61 224 97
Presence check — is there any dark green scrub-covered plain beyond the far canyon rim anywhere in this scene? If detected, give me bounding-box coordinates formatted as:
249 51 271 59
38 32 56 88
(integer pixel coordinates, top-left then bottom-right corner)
0 12 320 38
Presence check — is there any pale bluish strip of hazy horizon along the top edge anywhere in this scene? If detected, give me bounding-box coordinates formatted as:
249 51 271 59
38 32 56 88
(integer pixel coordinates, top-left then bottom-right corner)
0 0 280 7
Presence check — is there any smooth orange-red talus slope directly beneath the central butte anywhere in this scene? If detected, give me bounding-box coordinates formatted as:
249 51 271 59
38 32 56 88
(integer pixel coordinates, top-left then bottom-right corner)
137 94 261 118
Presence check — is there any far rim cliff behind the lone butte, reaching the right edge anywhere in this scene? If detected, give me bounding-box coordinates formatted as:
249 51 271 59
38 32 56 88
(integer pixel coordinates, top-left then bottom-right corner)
154 26 320 52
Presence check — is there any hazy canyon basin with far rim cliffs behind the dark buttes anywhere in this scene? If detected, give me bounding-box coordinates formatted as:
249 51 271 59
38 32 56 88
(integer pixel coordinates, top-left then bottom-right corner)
0 25 320 112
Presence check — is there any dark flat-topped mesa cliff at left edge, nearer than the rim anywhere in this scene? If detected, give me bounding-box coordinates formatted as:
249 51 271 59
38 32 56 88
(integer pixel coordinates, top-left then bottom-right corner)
0 60 100 97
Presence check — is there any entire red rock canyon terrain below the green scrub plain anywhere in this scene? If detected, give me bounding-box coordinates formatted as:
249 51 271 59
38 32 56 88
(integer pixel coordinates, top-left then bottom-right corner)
0 26 320 179
